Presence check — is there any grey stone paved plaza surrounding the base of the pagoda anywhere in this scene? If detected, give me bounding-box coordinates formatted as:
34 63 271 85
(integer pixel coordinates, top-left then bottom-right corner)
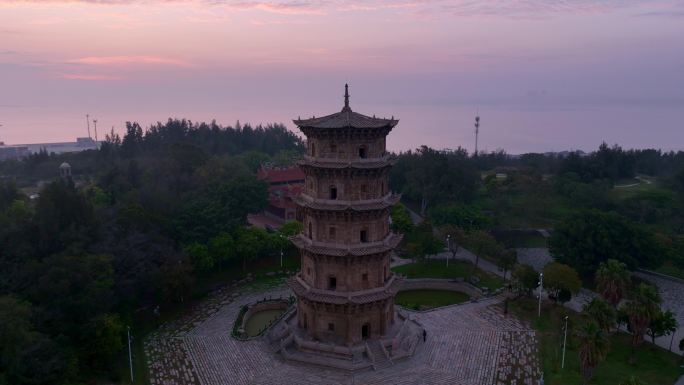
145 280 540 385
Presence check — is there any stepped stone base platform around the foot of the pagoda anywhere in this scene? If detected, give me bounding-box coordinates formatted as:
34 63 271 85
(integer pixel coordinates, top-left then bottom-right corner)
267 306 423 371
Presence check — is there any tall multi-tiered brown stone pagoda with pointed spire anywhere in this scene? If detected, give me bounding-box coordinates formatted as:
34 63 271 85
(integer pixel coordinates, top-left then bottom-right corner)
290 85 401 346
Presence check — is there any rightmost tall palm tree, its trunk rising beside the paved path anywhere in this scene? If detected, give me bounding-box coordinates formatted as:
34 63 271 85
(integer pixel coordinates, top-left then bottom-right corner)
623 283 661 363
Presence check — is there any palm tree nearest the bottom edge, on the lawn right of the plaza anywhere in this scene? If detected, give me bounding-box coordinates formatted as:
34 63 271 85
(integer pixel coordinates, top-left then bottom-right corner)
576 321 610 385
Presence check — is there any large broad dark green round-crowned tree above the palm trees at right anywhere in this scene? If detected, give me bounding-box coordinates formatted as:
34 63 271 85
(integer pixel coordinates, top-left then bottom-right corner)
549 210 664 278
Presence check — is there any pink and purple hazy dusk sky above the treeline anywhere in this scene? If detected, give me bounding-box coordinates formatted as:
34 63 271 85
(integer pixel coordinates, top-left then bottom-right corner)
0 0 684 153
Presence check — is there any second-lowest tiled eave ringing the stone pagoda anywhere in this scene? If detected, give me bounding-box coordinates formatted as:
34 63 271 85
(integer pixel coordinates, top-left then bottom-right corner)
290 233 403 257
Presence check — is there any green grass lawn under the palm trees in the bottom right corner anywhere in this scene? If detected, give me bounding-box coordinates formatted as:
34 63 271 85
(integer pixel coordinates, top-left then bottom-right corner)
509 299 684 385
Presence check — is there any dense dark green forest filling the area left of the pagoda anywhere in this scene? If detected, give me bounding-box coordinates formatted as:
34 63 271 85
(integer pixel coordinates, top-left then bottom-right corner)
0 120 302 385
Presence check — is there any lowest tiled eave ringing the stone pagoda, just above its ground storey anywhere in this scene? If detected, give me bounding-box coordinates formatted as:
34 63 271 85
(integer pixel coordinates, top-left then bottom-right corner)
288 275 403 305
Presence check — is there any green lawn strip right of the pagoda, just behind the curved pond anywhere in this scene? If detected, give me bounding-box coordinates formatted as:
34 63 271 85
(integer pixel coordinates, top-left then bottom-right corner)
392 261 504 290
